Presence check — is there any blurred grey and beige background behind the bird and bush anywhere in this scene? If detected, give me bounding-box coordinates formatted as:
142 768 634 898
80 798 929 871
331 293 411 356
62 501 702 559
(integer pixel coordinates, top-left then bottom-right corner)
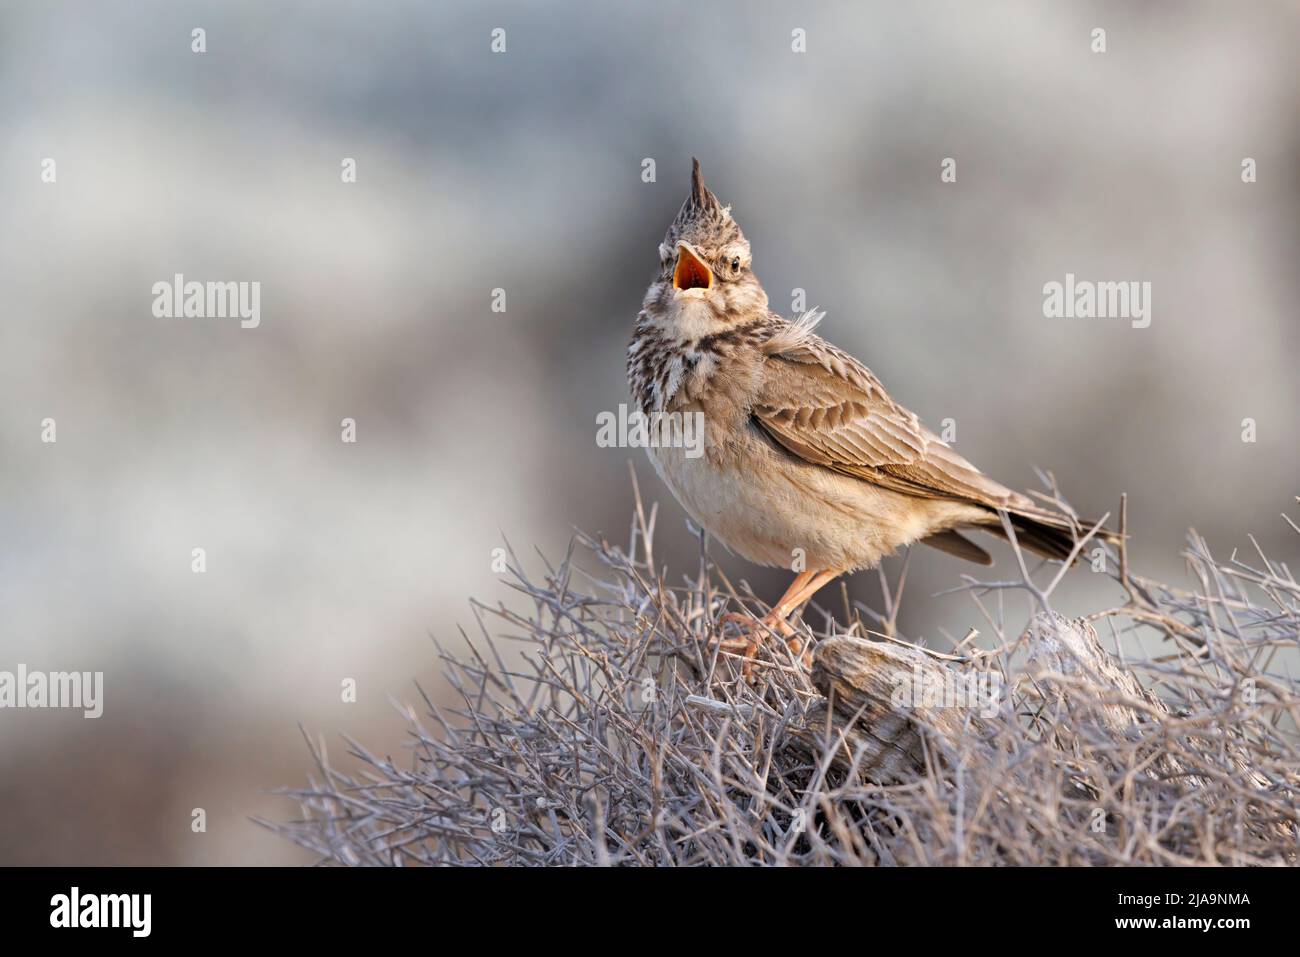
0 0 1300 863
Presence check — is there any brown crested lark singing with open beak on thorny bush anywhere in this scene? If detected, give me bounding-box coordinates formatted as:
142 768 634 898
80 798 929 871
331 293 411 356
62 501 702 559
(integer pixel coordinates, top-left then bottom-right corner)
628 160 1113 667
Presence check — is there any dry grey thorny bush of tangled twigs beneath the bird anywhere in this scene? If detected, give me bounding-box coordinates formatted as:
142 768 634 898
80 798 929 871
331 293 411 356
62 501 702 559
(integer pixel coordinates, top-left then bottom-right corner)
263 481 1300 865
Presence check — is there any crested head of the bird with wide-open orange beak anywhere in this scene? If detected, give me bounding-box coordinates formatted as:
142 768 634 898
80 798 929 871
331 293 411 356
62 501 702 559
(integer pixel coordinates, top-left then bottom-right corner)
645 160 767 338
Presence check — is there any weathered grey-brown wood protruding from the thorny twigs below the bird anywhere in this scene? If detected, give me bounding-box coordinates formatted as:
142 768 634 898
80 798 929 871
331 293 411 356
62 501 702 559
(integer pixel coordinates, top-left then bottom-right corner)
800 612 1197 788
